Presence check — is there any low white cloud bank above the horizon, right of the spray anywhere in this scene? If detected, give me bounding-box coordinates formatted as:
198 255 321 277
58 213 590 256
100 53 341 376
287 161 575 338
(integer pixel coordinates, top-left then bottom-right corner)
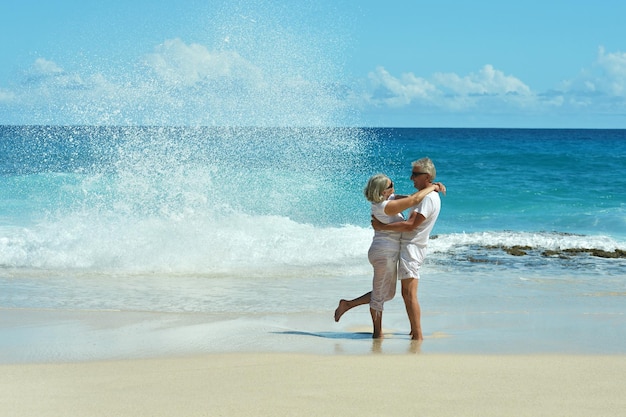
354 47 626 127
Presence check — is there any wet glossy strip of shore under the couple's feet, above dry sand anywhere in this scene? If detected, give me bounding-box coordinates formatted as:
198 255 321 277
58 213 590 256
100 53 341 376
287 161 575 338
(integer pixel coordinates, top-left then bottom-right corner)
0 300 626 364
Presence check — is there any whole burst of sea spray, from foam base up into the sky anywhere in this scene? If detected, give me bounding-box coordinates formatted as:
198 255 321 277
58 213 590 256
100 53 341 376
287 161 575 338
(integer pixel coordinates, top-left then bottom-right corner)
0 1 376 275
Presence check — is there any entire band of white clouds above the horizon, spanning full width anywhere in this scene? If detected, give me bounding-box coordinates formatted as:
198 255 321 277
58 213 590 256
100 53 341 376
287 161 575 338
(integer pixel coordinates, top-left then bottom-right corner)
0 39 626 126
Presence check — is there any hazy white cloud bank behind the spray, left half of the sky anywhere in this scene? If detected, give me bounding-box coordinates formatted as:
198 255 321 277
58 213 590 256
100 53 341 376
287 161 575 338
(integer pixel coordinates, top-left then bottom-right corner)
0 39 347 126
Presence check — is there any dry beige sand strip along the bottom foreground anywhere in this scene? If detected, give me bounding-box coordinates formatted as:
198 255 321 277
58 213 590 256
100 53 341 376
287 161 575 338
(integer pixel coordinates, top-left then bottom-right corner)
0 353 626 417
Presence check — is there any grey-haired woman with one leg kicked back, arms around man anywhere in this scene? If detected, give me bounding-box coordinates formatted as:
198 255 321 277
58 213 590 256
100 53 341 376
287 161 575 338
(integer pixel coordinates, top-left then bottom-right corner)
335 174 445 338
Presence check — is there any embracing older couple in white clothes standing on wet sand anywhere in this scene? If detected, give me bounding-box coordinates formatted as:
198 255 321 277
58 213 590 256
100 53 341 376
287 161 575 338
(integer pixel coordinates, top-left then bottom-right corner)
335 158 446 340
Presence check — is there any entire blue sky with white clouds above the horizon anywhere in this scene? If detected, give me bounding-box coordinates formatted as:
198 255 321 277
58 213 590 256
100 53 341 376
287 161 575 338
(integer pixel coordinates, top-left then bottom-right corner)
0 0 626 128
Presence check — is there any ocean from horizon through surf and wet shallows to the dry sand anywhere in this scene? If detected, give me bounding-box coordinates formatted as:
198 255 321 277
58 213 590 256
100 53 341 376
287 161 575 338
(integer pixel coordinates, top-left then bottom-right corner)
0 126 626 362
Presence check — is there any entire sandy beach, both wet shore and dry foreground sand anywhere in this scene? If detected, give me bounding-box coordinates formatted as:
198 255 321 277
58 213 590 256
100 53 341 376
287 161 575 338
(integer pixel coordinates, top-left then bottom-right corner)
0 283 626 417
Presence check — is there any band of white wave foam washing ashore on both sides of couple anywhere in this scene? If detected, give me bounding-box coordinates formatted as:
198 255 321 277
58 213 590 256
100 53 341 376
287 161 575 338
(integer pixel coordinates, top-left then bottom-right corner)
0 213 626 276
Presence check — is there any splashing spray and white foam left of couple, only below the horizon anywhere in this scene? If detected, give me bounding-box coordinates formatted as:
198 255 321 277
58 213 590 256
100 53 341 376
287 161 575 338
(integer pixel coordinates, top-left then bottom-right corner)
0 127 376 275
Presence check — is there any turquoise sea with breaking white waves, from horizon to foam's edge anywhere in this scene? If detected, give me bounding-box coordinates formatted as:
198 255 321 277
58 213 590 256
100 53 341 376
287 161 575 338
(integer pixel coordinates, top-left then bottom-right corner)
0 127 626 275
